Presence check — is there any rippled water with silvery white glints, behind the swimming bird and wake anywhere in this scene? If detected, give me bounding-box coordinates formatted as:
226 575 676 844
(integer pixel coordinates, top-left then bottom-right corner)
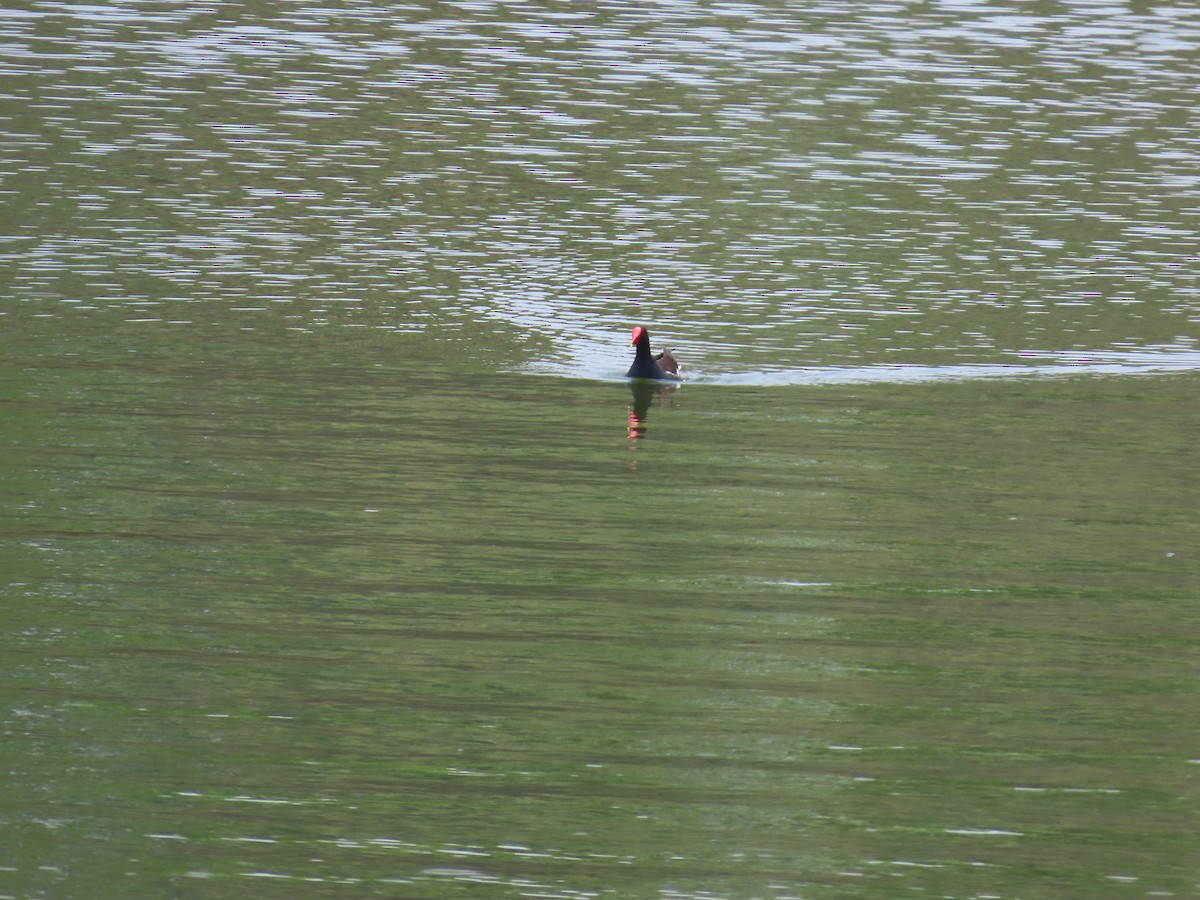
0 2 1200 376
